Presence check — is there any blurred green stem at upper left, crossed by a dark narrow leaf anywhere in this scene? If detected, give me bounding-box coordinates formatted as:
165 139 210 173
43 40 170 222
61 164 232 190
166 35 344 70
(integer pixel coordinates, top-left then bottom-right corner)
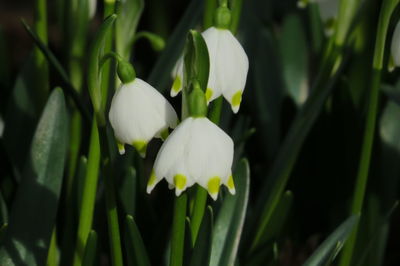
34 0 49 107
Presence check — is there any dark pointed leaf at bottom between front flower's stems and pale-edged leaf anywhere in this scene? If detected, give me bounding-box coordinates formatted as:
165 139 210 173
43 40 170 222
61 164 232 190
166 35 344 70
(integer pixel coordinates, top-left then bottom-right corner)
188 206 213 266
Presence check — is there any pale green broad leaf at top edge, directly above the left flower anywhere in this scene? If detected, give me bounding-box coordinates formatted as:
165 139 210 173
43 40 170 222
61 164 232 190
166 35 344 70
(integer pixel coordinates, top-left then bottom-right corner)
115 0 144 60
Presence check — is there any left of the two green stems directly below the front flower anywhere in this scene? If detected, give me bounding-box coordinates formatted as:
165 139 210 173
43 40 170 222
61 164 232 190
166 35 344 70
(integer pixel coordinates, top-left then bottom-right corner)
169 192 187 266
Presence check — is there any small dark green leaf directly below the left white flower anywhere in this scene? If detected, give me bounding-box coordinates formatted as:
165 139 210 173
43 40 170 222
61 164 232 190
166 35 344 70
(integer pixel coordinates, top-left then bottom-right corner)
118 167 137 216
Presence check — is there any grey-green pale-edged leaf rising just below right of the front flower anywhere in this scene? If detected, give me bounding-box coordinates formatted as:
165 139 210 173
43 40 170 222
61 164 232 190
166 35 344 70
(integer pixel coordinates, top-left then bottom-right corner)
209 159 250 266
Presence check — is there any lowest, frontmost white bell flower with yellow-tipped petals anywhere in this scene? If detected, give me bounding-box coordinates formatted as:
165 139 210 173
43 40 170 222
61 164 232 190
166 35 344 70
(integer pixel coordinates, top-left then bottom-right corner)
147 117 235 200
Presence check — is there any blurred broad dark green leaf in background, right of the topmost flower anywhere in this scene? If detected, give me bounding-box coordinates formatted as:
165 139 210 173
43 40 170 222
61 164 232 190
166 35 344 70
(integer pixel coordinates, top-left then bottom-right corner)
280 15 309 106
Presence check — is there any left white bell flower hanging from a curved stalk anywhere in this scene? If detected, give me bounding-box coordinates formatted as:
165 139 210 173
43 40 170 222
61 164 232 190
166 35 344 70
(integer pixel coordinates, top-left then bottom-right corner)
109 78 178 156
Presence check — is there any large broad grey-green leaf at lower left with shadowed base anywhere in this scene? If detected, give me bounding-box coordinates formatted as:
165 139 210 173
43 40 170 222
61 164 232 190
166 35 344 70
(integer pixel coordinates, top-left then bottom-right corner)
0 88 68 266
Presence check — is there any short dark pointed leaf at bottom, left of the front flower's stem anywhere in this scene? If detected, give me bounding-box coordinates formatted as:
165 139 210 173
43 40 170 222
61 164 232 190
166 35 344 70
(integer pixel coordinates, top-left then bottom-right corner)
125 215 150 266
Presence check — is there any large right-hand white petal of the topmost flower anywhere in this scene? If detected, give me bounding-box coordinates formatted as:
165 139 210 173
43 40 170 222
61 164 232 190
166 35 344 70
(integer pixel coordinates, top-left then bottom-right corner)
215 30 249 113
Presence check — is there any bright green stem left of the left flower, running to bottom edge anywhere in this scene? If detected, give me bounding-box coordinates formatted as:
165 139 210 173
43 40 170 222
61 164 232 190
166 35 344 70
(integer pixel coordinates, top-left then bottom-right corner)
73 117 100 266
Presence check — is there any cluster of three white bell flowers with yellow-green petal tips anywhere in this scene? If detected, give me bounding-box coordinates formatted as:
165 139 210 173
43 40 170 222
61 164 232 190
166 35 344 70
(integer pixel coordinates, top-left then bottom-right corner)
109 8 249 200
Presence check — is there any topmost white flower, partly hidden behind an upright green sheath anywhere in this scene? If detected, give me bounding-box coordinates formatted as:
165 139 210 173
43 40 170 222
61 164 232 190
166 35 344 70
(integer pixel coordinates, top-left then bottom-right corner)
171 27 249 113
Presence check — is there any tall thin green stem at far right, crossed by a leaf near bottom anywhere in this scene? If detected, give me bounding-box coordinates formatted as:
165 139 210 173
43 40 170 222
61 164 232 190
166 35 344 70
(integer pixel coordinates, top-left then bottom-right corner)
339 0 399 266
